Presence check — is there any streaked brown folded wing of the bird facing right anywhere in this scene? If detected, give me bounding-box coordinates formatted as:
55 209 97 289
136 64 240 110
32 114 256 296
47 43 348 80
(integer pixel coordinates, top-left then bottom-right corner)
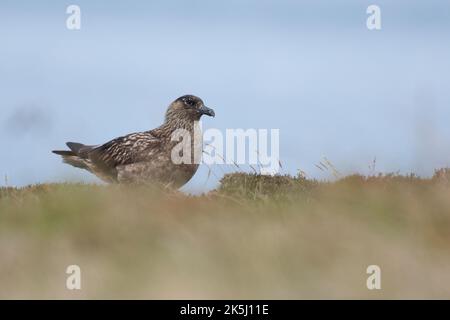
87 132 161 171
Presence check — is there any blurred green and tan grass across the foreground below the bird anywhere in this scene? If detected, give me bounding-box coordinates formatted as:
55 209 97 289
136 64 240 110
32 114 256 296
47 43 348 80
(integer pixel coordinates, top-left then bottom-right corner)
0 169 450 299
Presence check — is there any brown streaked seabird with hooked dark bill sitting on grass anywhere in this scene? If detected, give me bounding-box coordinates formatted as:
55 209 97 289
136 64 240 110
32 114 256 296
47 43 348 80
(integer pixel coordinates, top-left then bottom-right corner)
52 94 215 189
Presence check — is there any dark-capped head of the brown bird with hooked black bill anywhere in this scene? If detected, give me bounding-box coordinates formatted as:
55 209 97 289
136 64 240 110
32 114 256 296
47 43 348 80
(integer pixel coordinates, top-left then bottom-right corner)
166 95 215 120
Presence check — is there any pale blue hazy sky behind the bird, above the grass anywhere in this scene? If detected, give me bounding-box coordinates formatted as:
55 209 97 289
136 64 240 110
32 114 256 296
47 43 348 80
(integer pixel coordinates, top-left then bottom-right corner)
0 0 450 193
